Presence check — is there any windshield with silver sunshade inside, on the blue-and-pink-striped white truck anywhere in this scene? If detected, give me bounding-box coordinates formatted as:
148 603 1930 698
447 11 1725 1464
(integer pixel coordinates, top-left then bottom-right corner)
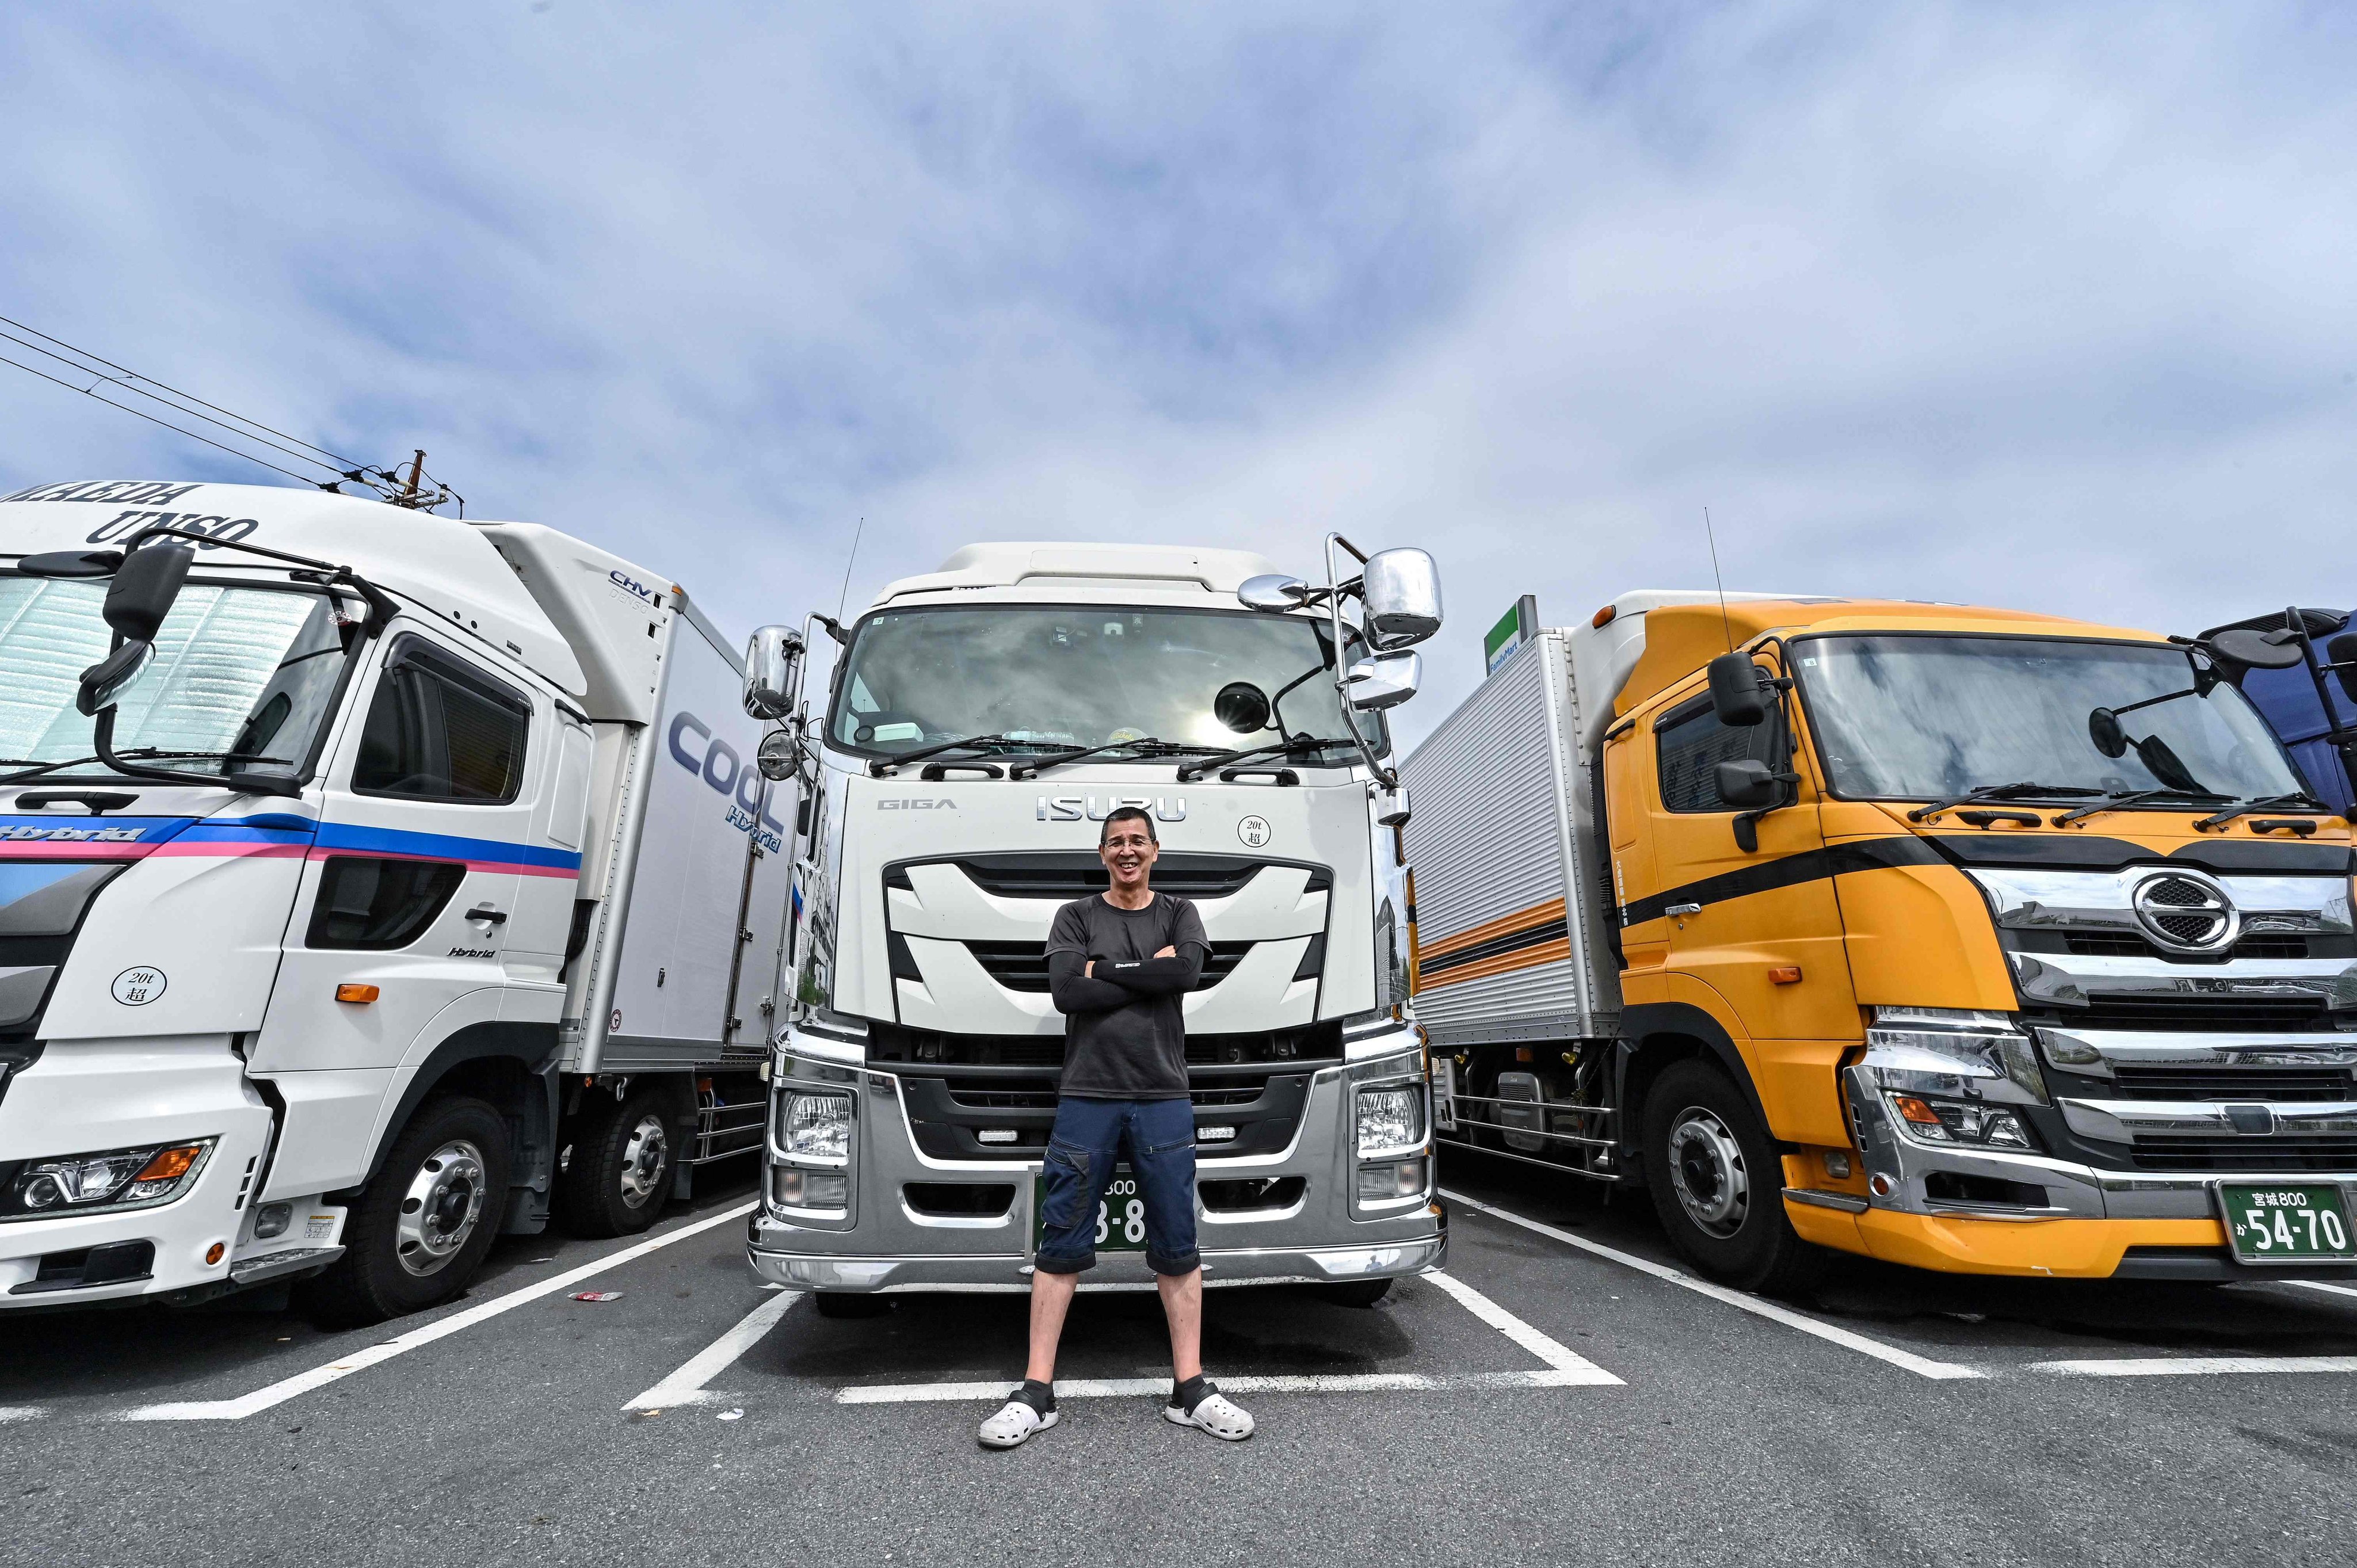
0 575 346 778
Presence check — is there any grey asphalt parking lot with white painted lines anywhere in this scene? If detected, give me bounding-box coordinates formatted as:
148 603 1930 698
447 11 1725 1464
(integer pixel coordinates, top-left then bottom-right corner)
0 1155 2357 1563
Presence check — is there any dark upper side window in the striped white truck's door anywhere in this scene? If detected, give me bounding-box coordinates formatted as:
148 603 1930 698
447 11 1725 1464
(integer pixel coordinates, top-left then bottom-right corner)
351 636 533 806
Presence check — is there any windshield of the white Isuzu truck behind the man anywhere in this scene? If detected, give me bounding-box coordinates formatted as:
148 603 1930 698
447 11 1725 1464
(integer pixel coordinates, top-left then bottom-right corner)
827 604 1383 757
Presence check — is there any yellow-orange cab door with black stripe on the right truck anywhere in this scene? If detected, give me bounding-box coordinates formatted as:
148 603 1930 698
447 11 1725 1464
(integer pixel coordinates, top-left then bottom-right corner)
1650 681 1858 1051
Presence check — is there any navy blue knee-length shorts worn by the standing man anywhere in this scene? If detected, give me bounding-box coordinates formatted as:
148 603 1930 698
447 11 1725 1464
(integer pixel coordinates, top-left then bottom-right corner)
1032 1096 1202 1273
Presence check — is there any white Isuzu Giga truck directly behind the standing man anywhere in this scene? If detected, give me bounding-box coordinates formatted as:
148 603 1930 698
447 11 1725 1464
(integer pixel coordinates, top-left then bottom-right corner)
747 537 1445 1316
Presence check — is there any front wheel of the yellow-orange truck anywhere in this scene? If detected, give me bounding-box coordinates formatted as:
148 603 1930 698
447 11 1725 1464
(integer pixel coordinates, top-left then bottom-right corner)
1645 1061 1822 1295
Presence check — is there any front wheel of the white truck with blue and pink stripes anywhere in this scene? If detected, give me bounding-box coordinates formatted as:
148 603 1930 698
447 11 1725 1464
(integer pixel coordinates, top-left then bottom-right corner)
302 1096 512 1327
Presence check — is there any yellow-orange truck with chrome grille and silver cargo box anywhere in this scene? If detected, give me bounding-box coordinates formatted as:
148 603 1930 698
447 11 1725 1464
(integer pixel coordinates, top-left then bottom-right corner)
1402 592 2357 1290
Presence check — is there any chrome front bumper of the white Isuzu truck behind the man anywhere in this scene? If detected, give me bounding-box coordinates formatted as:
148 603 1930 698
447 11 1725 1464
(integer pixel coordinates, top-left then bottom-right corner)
747 1031 1447 1292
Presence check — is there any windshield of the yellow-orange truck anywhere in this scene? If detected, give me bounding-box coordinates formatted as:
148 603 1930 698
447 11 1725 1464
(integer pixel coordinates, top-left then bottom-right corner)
1791 636 2305 809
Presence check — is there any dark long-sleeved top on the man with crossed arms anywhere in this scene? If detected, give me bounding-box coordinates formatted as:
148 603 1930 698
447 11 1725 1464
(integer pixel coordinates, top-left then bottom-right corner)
1047 894 1211 1099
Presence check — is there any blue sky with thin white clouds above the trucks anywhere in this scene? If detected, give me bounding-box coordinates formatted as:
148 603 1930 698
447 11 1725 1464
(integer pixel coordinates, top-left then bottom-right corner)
0 0 2357 733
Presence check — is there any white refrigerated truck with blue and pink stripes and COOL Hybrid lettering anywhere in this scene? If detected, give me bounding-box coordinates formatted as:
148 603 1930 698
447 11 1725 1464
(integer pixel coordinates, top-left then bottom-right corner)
0 481 792 1323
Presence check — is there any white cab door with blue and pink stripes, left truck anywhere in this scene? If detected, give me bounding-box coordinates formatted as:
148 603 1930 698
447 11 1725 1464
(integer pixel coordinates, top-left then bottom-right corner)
250 630 535 1193
